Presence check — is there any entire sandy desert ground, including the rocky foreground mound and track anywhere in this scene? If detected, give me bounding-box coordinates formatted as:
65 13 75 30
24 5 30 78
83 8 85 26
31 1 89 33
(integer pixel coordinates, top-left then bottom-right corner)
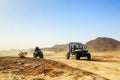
0 52 120 80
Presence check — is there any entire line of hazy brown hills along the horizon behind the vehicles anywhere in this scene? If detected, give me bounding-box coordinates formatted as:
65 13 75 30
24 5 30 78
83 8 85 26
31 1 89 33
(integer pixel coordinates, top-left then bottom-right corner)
0 37 120 53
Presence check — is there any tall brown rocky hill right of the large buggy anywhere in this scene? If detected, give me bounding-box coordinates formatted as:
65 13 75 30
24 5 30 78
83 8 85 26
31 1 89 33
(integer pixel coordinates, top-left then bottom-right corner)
86 37 120 51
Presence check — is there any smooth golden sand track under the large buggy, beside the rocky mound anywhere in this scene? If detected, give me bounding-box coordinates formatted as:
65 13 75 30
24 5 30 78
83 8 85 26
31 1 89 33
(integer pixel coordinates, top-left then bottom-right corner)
47 53 120 80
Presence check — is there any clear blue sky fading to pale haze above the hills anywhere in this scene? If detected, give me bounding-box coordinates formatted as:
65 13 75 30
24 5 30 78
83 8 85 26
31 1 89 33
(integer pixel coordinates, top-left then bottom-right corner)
0 0 120 50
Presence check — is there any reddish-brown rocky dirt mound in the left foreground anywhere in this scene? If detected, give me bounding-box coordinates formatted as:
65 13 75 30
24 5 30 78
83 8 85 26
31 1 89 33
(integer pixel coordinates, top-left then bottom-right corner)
0 57 108 80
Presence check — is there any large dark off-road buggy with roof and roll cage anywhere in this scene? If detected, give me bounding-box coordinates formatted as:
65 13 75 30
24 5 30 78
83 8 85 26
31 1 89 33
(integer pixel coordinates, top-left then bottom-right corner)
66 42 91 60
